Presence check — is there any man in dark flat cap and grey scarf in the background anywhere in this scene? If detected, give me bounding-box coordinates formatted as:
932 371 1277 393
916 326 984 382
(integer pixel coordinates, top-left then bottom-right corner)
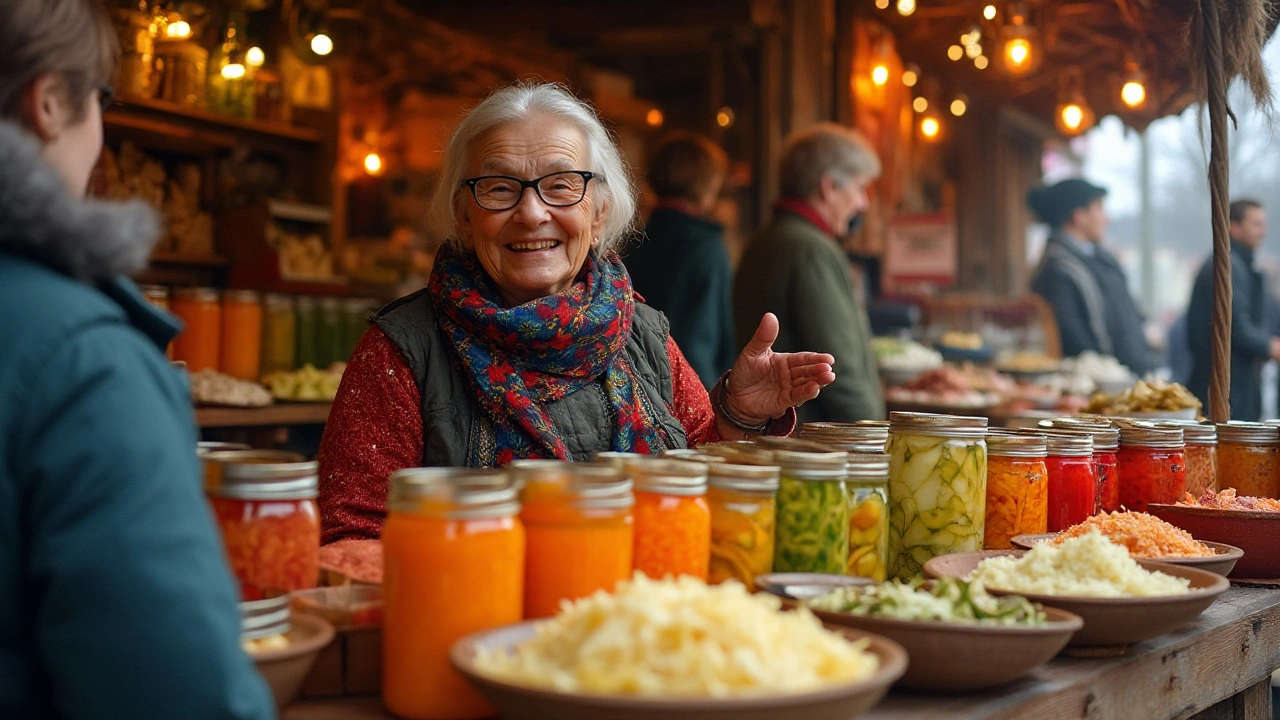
1027 178 1155 375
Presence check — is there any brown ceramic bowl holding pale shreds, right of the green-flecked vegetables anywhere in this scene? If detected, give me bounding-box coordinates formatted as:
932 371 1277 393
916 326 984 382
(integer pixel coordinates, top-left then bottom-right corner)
924 550 1231 646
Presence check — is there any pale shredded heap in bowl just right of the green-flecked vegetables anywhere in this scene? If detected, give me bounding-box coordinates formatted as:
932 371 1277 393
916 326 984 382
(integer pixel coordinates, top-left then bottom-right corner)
969 528 1190 597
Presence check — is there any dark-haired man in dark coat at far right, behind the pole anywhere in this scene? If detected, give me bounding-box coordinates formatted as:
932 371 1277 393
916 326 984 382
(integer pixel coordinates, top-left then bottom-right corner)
1187 200 1280 420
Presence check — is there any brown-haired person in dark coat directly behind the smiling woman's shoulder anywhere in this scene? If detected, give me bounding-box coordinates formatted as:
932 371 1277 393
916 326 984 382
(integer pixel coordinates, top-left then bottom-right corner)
626 132 736 387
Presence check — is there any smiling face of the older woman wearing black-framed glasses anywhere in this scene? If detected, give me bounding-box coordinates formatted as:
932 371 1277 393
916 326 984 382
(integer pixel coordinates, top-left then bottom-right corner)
458 117 604 306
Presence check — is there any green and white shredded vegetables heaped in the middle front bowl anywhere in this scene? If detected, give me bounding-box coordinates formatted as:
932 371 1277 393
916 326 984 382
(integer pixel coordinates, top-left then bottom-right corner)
806 578 1046 626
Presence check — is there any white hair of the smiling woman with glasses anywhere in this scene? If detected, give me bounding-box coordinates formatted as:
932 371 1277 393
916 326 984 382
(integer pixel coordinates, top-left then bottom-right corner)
429 82 636 254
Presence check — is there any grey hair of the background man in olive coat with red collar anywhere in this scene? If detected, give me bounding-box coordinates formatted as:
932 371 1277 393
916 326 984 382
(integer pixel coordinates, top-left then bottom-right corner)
778 123 881 197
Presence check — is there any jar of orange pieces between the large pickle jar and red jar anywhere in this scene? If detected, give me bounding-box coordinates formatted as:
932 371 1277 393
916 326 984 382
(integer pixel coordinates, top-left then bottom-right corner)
982 434 1048 550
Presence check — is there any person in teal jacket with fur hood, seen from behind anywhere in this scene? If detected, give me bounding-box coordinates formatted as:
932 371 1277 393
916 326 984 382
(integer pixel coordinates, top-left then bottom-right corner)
0 0 275 720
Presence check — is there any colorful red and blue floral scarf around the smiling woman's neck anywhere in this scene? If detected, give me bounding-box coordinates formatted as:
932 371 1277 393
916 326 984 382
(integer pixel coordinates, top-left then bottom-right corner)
428 247 662 466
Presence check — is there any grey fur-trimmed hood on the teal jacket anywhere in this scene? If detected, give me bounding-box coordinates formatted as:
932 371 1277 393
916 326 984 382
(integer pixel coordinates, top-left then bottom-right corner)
0 122 160 283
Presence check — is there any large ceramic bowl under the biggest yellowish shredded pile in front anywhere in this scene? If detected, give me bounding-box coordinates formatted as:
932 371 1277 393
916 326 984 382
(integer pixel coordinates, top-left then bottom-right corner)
449 621 906 720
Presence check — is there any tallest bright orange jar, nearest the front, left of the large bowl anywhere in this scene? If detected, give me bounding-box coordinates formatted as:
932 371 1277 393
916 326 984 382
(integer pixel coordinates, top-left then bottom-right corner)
383 468 525 720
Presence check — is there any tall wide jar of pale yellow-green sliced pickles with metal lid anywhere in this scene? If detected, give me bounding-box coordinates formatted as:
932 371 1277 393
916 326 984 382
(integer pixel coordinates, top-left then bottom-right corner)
888 413 987 579
